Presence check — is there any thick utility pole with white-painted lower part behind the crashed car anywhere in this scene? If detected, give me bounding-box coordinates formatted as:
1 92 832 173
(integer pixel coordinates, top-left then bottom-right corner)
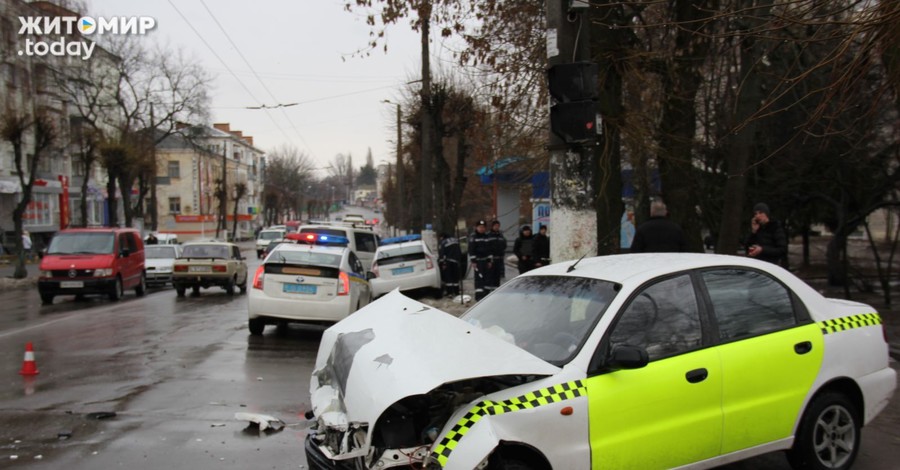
546 0 597 262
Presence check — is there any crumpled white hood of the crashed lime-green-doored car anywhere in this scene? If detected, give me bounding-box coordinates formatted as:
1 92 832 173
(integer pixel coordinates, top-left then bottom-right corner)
310 290 560 429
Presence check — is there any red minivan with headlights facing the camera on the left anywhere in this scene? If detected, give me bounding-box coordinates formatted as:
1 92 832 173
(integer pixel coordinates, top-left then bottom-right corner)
38 228 146 305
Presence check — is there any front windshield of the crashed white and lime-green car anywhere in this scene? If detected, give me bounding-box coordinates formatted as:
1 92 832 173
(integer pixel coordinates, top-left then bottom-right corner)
461 276 618 366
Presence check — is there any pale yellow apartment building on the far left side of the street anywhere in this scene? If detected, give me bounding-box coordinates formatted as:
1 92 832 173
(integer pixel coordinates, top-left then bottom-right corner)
156 123 265 241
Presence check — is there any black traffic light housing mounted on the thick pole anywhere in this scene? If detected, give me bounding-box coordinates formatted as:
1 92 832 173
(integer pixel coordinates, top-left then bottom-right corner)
547 62 599 144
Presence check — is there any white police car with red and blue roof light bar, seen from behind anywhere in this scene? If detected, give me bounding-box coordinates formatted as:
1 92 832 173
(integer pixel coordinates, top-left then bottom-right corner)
248 233 372 335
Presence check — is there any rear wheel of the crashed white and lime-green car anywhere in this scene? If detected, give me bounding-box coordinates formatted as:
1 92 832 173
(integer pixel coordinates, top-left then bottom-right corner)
788 391 860 470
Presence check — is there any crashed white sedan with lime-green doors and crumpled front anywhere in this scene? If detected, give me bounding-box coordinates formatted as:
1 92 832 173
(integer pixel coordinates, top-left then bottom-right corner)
306 254 896 470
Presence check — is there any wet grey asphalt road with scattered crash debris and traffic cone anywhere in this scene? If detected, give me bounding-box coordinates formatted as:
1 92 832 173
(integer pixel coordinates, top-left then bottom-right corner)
0 241 900 470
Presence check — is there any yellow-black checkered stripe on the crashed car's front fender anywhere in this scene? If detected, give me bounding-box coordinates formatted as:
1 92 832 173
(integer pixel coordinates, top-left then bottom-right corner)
431 380 587 467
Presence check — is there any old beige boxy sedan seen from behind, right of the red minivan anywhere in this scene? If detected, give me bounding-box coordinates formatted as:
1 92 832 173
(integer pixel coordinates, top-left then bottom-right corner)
172 242 247 297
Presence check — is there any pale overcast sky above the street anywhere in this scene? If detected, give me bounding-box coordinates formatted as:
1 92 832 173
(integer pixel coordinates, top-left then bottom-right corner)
87 0 428 175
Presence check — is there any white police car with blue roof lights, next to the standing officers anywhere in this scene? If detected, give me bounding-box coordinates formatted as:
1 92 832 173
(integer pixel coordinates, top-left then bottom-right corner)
369 235 441 298
